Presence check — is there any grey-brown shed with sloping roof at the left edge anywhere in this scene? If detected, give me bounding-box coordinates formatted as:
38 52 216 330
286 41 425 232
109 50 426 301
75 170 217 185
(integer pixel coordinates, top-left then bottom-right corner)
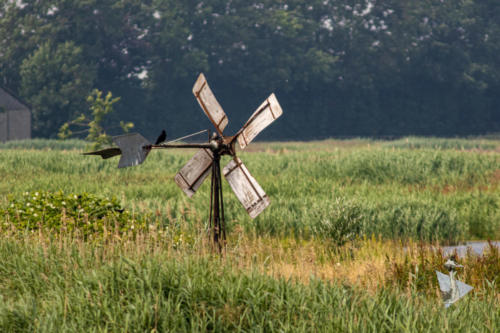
0 87 31 142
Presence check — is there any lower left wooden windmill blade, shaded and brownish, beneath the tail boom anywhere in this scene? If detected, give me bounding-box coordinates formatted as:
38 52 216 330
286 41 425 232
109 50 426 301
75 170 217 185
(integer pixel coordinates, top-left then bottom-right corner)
175 148 214 198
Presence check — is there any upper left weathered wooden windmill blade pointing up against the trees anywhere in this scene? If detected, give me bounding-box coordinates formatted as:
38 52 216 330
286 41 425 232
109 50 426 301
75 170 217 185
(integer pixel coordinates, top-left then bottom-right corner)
193 73 228 136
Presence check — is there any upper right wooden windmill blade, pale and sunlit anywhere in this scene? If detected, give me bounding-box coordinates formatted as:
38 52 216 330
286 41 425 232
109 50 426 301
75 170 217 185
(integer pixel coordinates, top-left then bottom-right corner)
237 94 283 149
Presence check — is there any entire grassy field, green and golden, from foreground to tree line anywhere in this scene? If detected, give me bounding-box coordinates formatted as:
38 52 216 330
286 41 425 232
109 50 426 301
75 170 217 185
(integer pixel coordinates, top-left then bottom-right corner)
0 138 500 332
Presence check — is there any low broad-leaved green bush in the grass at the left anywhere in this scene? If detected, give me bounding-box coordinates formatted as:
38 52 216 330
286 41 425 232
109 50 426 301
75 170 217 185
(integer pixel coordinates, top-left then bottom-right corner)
3 191 145 237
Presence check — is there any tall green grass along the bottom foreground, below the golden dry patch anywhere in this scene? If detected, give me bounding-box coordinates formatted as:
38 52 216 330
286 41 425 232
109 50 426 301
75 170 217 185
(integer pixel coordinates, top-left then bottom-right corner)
0 239 500 332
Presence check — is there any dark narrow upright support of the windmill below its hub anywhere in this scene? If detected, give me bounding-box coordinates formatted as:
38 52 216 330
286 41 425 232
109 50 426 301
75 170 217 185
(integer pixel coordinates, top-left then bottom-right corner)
210 154 226 252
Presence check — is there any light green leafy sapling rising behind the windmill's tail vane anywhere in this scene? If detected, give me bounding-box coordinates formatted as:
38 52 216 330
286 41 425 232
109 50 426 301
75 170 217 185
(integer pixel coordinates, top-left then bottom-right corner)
58 89 134 149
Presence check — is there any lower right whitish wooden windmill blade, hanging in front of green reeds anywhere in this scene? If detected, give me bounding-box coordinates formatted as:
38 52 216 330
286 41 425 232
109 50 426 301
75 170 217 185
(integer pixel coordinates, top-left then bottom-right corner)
223 157 270 218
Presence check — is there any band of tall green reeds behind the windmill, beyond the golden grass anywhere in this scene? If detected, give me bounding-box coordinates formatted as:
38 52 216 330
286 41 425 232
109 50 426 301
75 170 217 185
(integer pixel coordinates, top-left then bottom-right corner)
0 147 500 242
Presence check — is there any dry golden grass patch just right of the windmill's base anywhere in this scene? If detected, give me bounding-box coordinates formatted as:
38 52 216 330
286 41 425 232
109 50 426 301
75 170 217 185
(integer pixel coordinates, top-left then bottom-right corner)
224 232 392 290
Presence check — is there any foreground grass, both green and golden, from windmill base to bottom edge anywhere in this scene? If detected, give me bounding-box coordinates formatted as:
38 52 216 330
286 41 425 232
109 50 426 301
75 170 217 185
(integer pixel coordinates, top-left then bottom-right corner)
0 230 500 332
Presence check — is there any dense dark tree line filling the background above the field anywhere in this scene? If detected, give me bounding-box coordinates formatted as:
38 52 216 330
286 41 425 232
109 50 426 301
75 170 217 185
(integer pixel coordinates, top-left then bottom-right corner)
0 0 500 139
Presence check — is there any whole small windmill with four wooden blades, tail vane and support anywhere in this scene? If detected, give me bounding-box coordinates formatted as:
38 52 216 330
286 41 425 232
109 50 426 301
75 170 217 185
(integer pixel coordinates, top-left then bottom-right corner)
84 73 283 249
